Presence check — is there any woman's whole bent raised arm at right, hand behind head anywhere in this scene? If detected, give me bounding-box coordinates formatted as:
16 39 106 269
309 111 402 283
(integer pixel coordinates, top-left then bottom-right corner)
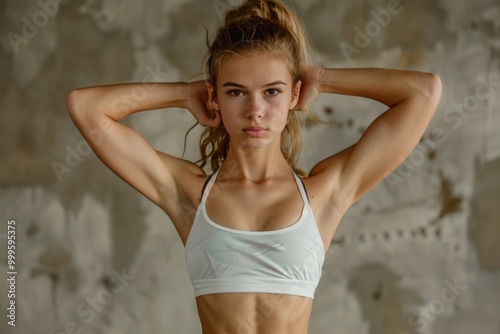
300 68 441 205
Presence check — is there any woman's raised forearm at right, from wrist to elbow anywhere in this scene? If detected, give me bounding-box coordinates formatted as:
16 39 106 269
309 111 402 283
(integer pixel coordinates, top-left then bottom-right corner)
319 68 440 107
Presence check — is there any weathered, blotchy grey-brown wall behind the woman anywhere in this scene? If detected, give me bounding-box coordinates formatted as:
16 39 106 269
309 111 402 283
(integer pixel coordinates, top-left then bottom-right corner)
0 0 500 334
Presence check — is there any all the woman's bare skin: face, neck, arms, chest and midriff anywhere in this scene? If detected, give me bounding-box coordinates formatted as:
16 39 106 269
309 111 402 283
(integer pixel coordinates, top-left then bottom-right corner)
68 54 441 334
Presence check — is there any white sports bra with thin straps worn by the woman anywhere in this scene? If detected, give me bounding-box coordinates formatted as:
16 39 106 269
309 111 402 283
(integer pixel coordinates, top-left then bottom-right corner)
185 170 325 299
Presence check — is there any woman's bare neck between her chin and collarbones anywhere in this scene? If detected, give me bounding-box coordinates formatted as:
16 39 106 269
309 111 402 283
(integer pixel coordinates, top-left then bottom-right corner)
221 140 291 183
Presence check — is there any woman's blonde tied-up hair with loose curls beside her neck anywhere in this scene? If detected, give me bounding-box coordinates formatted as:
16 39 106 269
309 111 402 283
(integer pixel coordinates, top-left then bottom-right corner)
198 0 311 176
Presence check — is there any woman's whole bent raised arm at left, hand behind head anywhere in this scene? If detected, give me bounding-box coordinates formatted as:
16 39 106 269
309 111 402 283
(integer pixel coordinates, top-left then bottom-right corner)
67 82 219 222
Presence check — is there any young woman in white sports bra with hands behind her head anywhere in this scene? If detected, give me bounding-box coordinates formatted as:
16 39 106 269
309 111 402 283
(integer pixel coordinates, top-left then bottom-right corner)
68 0 441 334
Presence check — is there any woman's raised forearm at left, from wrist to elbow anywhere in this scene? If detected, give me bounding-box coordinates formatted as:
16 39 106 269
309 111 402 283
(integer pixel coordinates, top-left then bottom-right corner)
67 83 186 121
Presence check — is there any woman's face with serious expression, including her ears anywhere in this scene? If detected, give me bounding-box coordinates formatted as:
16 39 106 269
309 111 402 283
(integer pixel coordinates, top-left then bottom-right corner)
212 53 300 148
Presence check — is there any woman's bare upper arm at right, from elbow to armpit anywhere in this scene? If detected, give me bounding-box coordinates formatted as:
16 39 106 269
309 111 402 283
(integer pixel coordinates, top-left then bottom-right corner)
311 92 437 203
